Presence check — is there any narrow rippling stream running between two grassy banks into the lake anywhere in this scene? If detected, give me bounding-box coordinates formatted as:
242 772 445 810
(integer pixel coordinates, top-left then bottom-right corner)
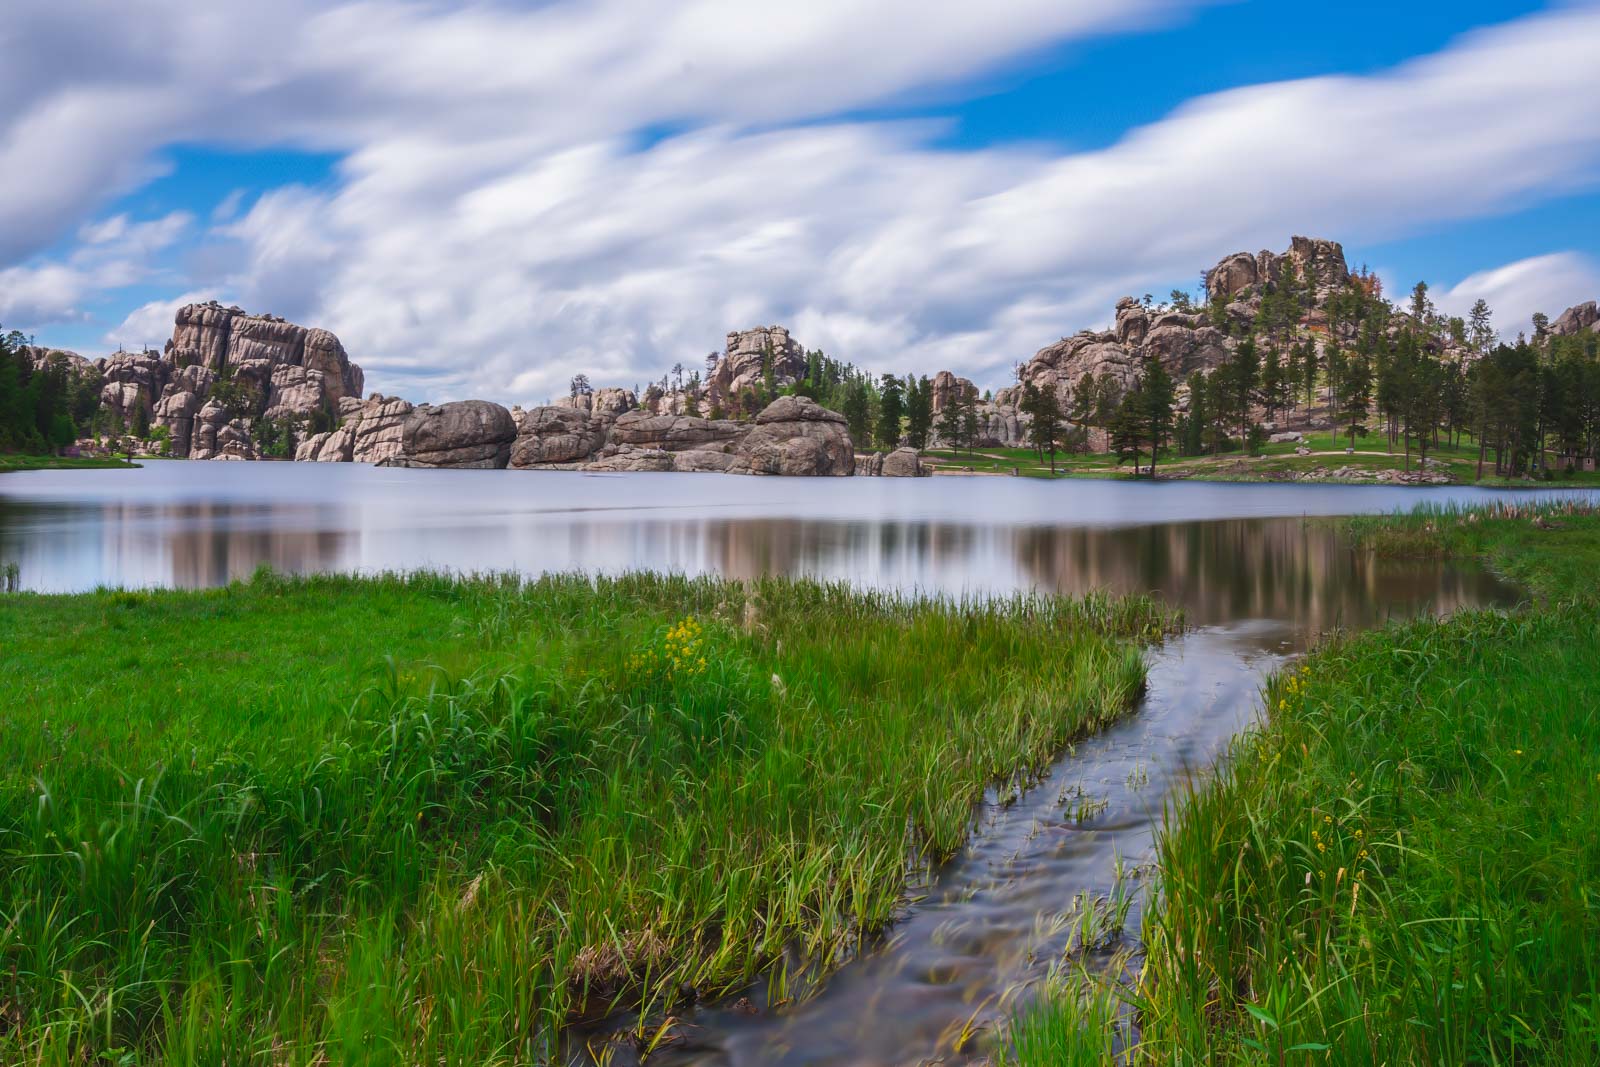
574 619 1304 1067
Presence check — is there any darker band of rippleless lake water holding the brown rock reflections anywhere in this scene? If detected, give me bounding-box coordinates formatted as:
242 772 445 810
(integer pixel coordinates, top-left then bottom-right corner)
0 499 1504 630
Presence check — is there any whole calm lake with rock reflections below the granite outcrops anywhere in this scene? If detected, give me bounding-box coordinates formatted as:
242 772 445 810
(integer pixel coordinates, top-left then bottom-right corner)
0 462 1574 625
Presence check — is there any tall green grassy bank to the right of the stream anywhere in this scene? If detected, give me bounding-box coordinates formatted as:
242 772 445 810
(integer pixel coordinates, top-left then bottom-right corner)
1010 504 1600 1064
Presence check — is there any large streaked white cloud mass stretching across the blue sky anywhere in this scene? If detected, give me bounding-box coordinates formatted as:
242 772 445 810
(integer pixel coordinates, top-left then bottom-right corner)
0 0 1600 402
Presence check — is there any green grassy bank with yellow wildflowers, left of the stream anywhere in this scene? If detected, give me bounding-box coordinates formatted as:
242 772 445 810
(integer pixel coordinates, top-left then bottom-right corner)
0 576 1166 1064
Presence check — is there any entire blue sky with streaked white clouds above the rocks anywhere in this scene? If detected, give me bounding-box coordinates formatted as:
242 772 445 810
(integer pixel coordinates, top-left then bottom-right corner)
0 0 1600 405
